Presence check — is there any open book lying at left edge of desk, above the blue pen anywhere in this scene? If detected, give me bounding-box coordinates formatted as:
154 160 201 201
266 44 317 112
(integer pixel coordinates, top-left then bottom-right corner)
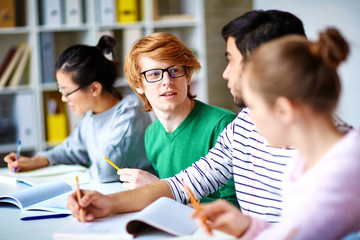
0 182 72 220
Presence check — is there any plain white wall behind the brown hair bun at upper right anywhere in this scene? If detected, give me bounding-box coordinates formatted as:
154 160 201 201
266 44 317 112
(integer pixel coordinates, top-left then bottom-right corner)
253 0 360 128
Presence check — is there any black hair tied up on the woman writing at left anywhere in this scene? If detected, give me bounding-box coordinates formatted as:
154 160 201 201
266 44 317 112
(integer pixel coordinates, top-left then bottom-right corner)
55 35 121 98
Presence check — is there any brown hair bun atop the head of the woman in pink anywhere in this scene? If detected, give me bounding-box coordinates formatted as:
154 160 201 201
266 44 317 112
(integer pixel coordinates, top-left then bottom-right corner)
318 28 349 68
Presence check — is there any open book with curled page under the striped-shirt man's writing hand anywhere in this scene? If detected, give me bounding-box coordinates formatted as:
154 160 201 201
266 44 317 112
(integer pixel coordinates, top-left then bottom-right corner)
54 197 197 239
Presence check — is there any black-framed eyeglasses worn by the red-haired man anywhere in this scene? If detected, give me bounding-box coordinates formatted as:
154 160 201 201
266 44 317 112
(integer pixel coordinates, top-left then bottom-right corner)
141 65 186 83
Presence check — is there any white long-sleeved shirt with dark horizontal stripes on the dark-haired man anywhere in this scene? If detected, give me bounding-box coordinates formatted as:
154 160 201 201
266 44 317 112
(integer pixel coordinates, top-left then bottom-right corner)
165 108 348 223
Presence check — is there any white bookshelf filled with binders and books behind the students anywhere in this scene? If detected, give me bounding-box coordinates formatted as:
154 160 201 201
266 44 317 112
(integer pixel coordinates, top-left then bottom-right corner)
0 0 208 156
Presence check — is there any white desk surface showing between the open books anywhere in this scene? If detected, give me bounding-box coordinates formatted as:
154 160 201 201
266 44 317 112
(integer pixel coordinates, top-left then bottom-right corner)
0 169 174 240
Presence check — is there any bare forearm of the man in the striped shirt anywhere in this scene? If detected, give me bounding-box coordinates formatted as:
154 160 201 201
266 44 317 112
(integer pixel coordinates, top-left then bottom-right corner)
108 181 174 213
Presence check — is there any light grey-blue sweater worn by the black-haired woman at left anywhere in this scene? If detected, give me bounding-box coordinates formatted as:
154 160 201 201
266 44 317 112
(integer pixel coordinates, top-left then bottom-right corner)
38 95 154 182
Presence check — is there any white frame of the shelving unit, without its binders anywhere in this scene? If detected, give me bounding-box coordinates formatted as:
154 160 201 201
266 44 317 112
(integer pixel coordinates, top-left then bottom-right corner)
0 0 208 154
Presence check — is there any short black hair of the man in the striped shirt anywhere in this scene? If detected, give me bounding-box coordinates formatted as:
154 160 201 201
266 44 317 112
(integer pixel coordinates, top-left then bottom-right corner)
222 10 306 60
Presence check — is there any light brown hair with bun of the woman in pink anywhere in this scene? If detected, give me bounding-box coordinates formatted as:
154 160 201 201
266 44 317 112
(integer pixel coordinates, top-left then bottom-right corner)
245 28 349 113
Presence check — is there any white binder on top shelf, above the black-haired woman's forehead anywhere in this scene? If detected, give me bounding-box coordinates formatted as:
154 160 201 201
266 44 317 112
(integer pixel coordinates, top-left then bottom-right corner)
64 0 82 26
